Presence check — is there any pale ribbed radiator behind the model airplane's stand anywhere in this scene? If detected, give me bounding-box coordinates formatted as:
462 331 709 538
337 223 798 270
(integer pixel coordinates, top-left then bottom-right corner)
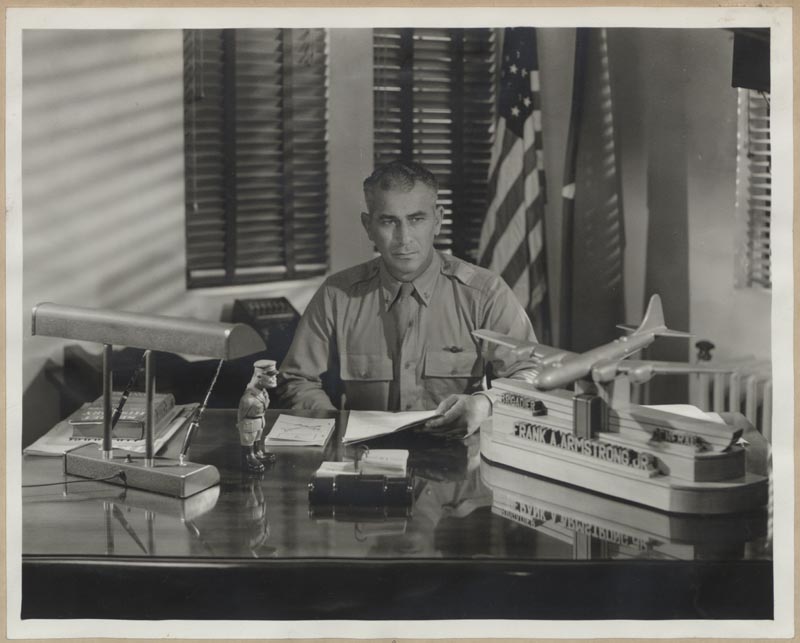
689 361 772 442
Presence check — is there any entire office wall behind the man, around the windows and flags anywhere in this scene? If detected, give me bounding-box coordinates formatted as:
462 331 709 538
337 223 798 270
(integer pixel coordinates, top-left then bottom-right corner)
21 29 770 446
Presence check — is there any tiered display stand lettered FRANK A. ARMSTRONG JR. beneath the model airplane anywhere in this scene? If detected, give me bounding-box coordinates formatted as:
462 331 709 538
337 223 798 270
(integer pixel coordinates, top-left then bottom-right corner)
481 379 768 514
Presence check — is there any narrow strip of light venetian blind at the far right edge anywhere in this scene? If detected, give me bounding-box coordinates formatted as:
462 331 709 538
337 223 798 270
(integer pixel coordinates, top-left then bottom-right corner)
740 89 772 288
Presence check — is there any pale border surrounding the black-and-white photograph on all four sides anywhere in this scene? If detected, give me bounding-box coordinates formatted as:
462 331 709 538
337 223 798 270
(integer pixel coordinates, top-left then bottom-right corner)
5 7 794 638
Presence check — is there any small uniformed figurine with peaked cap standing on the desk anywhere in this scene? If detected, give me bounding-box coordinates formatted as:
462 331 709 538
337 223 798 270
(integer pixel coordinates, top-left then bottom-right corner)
236 359 278 473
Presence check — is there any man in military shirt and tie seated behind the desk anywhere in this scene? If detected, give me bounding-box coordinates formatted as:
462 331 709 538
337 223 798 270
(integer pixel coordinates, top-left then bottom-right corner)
281 161 536 437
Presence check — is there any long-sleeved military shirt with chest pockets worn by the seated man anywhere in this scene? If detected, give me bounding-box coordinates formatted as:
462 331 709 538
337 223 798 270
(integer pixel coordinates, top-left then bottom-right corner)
280 252 535 411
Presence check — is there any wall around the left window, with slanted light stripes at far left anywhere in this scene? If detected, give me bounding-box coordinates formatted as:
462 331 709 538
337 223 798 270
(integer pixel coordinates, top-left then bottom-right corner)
20 30 372 443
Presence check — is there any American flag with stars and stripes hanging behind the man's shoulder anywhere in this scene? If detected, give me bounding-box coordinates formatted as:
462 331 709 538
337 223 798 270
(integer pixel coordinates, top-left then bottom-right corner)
478 27 550 341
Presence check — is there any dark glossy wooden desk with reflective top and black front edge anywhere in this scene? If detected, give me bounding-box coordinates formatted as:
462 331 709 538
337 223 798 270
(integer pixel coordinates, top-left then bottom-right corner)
22 410 772 620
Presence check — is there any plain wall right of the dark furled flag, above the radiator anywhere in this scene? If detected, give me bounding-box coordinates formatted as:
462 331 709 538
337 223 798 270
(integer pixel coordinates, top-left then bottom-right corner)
609 29 771 368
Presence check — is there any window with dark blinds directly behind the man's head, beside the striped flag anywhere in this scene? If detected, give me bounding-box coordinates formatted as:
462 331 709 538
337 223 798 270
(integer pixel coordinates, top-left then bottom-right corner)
374 29 496 262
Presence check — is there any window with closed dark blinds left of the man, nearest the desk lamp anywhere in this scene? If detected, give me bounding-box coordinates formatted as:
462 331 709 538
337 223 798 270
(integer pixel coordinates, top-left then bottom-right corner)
184 29 328 288
